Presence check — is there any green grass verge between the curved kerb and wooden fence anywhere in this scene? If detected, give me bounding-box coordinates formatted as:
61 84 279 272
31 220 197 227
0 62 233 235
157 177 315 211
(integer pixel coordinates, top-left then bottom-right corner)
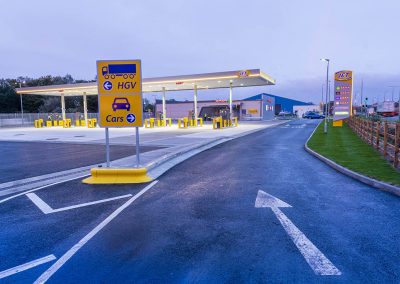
308 122 400 186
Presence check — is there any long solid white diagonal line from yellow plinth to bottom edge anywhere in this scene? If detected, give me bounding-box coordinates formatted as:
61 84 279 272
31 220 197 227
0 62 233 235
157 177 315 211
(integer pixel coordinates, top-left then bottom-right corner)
34 180 158 284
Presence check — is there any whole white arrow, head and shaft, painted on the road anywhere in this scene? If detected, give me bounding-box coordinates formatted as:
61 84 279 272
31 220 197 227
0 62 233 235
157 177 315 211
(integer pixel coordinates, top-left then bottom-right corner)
255 190 342 275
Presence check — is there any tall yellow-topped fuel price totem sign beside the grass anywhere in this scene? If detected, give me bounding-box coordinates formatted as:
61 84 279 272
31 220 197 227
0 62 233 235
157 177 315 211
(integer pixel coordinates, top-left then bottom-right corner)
333 70 353 126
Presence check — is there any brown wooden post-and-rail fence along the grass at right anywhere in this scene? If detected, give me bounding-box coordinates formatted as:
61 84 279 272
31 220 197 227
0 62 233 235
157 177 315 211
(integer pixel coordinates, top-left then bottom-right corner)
348 117 400 168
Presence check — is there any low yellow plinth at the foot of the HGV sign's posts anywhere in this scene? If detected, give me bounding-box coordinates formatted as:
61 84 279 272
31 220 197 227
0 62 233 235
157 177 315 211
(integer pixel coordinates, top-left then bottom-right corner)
82 168 153 184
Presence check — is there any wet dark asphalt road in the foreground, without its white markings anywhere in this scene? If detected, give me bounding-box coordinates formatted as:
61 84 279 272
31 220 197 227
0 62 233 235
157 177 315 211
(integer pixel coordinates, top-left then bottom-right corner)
0 120 400 283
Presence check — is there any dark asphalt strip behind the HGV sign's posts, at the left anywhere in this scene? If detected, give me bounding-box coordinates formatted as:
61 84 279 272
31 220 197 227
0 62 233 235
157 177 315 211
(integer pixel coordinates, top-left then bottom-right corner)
0 142 158 183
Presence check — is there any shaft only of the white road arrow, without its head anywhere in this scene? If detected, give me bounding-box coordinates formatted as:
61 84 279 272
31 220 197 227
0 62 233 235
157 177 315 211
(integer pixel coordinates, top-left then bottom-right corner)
271 207 342 275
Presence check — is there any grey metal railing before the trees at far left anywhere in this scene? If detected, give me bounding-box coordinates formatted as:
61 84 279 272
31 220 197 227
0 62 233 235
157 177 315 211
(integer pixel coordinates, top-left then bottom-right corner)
0 113 98 127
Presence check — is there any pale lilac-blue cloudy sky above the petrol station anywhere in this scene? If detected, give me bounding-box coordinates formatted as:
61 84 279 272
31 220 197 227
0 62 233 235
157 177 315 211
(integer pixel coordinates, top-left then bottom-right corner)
0 0 400 103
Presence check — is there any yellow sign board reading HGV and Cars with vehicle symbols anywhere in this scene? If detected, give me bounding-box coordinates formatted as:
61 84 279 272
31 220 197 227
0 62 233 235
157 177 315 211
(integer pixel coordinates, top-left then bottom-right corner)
97 60 143 127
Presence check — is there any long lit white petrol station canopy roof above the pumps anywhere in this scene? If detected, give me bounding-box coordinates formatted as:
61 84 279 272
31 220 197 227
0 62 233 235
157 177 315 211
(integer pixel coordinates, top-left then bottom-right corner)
17 69 275 96
